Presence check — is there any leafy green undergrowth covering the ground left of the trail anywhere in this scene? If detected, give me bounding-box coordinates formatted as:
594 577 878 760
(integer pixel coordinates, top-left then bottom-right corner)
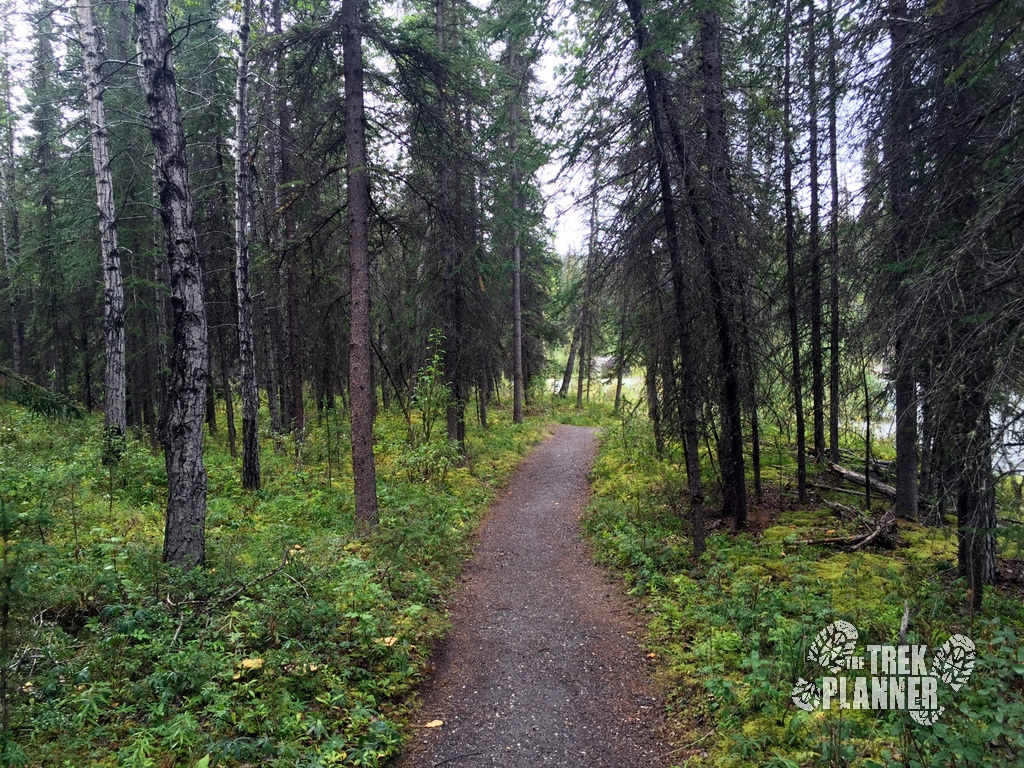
0 403 547 768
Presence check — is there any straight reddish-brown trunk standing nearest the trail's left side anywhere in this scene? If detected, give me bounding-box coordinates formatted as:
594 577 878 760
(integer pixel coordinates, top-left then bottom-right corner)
341 0 378 531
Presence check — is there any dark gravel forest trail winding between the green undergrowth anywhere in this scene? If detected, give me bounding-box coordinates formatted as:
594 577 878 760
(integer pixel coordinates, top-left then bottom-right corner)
397 426 668 768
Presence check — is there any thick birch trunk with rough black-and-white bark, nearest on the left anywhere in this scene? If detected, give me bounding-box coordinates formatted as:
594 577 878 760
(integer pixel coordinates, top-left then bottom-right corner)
135 0 209 568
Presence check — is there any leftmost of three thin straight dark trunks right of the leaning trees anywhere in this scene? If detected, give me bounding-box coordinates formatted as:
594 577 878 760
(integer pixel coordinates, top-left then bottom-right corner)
782 0 807 503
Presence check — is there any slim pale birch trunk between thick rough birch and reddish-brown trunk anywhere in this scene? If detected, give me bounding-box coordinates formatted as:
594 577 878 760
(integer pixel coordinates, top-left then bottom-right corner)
234 0 260 490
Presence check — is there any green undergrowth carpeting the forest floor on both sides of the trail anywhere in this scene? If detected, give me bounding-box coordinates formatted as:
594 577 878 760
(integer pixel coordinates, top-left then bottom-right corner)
8 368 1024 768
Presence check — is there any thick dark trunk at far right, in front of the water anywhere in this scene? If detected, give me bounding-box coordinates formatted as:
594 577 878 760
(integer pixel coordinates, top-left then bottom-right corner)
932 0 1004 613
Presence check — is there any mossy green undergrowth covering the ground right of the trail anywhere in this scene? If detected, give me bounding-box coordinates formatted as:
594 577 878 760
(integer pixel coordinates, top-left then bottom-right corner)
585 411 1024 768
